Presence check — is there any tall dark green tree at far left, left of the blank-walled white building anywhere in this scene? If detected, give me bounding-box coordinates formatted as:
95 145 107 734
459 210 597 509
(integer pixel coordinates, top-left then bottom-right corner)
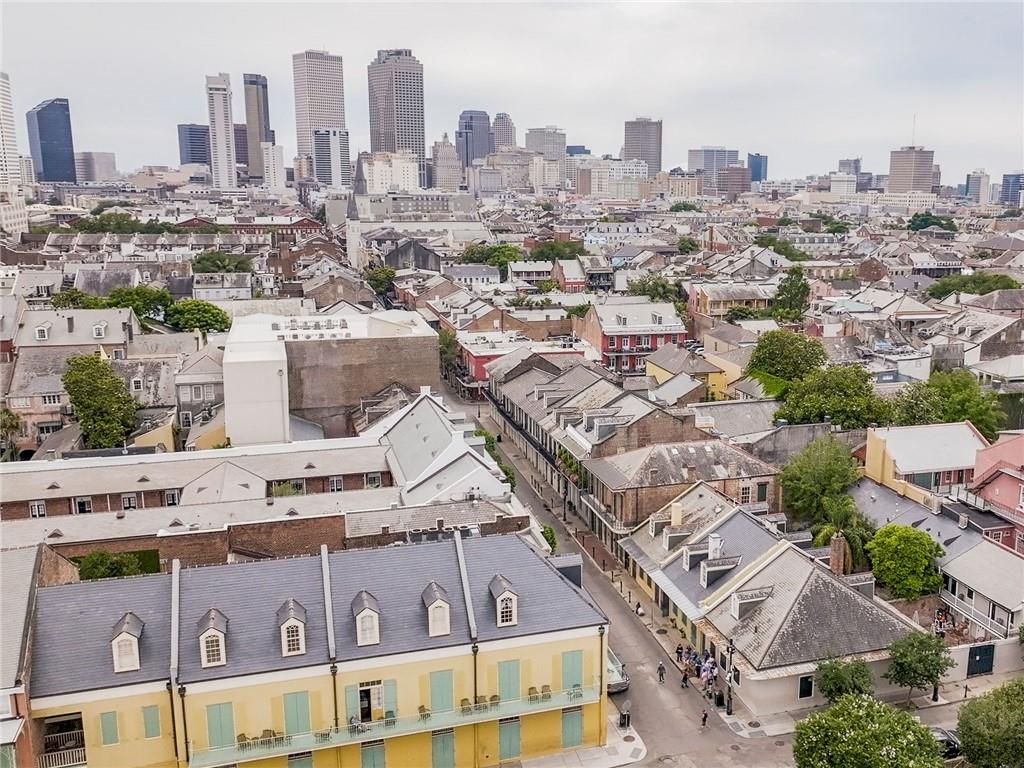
60 354 138 449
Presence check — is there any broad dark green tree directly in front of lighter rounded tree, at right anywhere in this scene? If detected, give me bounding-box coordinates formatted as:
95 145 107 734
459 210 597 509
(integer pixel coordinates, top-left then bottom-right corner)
770 364 889 429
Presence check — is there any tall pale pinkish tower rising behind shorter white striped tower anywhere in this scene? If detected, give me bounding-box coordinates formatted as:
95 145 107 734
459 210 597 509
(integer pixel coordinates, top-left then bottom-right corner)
292 50 351 167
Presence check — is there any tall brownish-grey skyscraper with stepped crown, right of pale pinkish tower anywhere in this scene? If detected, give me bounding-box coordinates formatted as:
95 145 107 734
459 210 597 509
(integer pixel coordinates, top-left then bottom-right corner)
367 48 427 187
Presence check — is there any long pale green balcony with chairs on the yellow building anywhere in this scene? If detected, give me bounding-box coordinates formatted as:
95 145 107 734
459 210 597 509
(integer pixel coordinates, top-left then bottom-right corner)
188 686 601 768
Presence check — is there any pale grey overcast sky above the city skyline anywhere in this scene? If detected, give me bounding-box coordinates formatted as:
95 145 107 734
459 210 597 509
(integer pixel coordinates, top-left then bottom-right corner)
0 0 1024 184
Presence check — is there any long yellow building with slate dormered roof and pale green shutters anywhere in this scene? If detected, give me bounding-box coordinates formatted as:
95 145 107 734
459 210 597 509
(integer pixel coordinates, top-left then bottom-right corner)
31 531 607 768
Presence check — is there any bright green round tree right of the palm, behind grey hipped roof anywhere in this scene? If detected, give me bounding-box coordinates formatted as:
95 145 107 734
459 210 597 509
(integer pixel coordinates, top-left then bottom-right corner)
867 523 943 600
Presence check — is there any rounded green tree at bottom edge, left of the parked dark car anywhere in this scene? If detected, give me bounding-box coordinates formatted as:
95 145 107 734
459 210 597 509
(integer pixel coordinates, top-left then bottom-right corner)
793 695 942 768
